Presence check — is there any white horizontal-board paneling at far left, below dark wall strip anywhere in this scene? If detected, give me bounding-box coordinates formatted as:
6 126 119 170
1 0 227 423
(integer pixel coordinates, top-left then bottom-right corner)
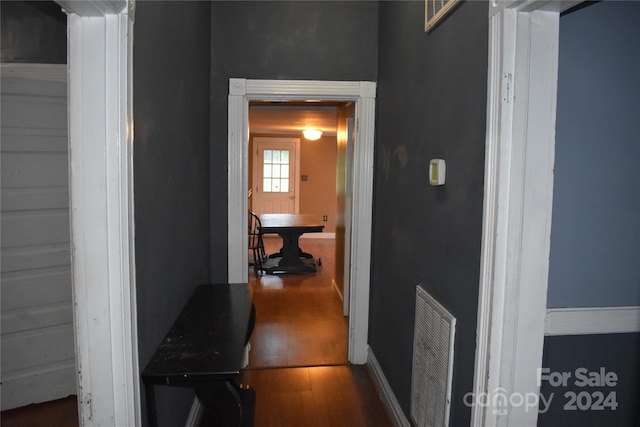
1 65 76 410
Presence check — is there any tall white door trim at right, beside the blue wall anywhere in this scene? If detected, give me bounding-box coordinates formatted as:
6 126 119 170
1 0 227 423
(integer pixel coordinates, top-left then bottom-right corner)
471 0 578 426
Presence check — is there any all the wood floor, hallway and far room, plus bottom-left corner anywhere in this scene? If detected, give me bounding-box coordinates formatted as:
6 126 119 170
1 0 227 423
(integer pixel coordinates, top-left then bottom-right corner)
2 238 392 427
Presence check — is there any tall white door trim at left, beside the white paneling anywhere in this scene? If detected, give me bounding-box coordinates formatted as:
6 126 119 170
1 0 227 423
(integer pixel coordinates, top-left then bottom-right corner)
58 0 141 426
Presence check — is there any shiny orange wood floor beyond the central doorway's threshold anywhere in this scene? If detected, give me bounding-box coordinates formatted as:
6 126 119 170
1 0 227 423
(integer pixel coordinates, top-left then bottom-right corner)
249 237 348 369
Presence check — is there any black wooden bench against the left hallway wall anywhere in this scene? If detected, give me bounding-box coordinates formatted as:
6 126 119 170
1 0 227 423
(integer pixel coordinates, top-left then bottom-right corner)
142 283 255 426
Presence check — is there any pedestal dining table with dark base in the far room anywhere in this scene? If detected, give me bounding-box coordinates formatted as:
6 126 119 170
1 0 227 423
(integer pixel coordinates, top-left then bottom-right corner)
260 214 324 274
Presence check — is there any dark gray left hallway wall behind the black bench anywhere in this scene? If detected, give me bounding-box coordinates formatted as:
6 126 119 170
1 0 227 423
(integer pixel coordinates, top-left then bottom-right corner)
133 1 211 426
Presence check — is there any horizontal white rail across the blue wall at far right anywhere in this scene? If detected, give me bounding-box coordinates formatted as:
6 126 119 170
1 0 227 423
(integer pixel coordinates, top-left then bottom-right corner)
544 306 640 336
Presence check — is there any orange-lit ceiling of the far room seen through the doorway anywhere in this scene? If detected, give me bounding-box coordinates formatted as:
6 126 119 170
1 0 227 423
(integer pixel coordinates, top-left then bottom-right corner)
249 106 337 135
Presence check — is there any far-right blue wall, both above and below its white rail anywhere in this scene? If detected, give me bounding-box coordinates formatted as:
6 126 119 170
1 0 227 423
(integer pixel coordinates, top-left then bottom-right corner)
538 1 640 427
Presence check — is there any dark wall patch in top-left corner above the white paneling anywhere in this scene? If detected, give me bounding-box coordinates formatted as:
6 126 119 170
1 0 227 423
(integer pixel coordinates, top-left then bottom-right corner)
0 1 67 64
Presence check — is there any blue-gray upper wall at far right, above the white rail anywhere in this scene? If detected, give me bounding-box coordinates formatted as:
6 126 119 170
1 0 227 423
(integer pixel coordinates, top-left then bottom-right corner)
548 1 640 307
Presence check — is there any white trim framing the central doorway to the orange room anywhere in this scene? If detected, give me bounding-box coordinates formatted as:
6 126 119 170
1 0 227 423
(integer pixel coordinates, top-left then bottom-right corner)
228 78 376 364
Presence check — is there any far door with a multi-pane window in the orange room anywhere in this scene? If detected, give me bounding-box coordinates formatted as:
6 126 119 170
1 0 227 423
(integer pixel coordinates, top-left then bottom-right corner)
251 137 300 214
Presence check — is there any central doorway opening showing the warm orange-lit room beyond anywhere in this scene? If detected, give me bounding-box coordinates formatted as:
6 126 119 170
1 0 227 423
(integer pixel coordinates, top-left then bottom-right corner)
248 101 353 369
